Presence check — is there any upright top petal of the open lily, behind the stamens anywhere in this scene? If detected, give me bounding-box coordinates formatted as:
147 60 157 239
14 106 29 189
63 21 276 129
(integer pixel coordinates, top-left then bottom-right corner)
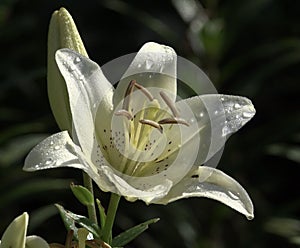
114 42 177 105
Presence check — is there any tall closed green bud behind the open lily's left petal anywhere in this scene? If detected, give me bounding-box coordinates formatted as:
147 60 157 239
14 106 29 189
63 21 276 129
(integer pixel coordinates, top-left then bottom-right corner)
47 8 88 134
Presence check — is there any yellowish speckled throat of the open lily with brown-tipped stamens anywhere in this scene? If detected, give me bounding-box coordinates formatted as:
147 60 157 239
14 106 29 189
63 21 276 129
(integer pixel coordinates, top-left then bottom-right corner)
95 80 190 177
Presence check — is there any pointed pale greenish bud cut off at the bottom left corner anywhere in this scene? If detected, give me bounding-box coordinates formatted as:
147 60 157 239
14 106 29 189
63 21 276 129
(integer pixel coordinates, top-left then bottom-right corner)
0 213 29 248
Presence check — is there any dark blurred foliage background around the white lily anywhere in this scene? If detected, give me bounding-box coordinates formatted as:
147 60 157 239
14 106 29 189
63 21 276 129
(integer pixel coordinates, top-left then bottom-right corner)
0 0 300 248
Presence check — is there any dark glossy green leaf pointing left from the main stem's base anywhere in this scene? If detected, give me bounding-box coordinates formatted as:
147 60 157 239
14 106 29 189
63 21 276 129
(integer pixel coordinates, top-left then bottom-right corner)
56 204 101 238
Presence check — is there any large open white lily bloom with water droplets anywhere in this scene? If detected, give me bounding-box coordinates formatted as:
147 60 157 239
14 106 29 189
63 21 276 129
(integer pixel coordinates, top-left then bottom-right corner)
24 42 255 219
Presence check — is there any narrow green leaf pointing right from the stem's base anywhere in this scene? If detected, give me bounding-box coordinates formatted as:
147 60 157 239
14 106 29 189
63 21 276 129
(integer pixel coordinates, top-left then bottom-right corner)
112 218 159 247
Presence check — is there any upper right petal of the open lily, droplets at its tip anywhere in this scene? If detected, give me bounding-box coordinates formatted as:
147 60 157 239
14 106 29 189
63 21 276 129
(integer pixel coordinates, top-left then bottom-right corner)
176 94 255 165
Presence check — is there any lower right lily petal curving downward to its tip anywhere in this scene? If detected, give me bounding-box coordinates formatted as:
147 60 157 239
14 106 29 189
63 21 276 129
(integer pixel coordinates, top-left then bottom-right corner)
154 166 254 219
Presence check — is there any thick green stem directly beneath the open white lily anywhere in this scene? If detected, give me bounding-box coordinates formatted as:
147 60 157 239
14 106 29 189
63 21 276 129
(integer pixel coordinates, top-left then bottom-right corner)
102 193 121 243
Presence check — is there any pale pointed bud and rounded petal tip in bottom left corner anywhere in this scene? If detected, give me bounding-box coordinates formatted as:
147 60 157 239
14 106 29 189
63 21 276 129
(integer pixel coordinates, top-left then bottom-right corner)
0 213 50 248
